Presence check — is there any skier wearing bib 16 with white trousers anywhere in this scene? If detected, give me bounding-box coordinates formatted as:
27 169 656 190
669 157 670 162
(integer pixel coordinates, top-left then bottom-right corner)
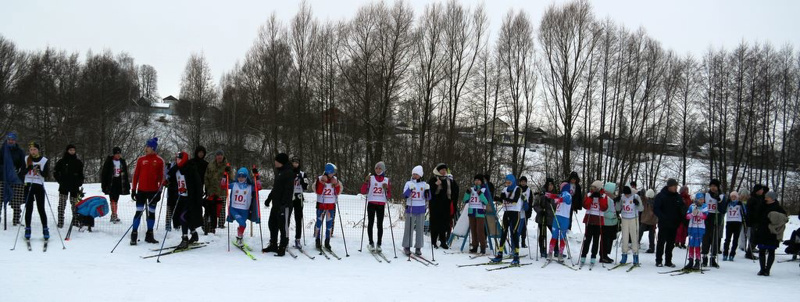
616 186 644 266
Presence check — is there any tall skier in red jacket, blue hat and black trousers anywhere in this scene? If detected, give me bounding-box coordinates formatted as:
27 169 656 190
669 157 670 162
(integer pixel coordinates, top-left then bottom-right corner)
131 137 164 245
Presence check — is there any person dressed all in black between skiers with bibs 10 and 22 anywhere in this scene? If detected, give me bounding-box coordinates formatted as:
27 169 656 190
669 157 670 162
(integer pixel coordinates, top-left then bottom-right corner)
262 153 296 256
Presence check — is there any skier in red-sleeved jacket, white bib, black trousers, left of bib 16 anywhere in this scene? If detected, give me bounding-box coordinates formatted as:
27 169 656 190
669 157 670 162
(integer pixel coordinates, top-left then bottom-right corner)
581 180 608 265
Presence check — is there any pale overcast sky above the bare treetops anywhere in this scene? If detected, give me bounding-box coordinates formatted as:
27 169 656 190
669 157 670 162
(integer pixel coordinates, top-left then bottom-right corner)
0 0 800 97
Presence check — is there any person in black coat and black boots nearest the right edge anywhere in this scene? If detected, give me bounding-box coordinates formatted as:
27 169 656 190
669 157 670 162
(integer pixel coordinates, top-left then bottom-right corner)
755 192 786 276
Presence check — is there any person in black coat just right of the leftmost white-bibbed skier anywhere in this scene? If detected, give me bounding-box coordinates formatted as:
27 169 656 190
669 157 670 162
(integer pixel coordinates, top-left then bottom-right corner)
53 144 84 228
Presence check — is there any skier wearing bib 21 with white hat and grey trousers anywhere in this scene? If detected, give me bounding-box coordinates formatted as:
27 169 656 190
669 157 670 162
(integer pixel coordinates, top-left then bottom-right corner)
403 166 431 256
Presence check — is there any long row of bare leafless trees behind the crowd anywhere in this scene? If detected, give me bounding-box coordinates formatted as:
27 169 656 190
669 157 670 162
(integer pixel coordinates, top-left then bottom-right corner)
0 0 800 212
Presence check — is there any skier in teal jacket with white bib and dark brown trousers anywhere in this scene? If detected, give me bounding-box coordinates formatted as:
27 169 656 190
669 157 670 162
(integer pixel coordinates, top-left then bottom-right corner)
463 174 489 255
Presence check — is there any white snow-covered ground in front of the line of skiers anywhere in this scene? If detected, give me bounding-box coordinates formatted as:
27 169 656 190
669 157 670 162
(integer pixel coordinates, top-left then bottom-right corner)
0 184 800 301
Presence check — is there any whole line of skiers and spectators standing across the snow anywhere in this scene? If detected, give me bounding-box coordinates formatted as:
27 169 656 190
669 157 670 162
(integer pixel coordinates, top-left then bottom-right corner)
0 132 788 276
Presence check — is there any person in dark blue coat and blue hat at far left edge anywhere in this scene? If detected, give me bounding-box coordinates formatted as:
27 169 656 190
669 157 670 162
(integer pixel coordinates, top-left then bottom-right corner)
0 132 26 226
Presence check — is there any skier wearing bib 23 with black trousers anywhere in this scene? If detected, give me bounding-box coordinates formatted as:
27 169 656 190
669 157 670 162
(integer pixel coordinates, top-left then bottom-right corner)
361 161 392 252
